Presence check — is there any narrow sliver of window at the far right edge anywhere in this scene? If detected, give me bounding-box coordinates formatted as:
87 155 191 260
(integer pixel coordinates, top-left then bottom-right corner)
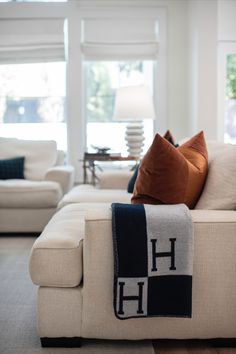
224 54 236 144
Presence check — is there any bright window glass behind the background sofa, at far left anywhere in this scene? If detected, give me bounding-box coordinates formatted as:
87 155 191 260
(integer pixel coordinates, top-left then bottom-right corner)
0 62 67 150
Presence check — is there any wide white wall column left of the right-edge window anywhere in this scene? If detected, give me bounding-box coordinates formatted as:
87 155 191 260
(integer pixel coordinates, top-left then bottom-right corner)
188 0 217 139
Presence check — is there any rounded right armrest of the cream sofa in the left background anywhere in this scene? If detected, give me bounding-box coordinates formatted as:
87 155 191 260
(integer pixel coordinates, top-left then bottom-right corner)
44 165 74 195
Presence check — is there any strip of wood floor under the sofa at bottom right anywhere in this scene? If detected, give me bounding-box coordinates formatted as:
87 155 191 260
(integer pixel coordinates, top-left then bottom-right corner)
153 341 236 354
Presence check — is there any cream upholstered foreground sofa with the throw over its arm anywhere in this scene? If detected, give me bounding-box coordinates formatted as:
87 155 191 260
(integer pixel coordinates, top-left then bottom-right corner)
29 140 236 346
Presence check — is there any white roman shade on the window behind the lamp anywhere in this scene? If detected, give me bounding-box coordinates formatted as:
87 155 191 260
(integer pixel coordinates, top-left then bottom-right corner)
81 18 158 60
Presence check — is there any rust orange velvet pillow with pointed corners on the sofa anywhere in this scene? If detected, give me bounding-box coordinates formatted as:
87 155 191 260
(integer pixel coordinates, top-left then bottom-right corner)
132 132 208 209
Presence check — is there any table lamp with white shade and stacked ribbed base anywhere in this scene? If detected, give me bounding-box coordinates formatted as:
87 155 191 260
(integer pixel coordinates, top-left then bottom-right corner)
113 86 155 157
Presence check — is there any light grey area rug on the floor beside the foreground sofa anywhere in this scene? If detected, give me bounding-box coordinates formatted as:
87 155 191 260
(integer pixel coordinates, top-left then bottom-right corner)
0 236 154 354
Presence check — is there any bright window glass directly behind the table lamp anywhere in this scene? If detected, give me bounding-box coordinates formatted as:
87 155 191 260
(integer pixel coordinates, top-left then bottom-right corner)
85 60 154 154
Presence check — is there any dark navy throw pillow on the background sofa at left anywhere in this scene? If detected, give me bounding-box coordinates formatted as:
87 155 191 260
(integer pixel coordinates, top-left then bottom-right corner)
0 157 25 179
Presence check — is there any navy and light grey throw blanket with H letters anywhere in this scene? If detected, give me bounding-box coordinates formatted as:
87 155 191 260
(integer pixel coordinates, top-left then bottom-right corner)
112 203 193 319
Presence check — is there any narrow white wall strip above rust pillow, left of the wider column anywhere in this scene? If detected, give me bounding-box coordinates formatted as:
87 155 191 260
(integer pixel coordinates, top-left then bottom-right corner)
165 0 189 139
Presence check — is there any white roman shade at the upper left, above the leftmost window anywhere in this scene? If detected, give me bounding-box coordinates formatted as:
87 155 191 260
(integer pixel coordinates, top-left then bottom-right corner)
0 19 65 64
